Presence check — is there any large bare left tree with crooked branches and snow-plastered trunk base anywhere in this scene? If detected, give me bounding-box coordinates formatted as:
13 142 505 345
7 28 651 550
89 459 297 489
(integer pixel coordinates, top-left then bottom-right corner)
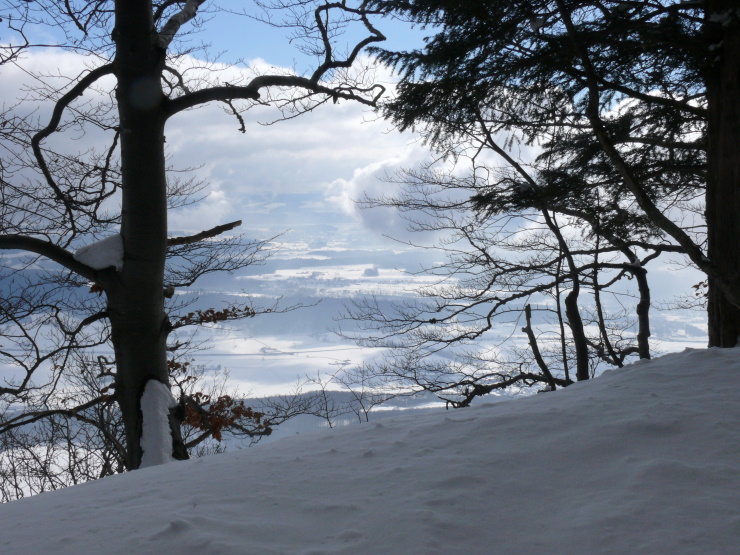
0 0 384 469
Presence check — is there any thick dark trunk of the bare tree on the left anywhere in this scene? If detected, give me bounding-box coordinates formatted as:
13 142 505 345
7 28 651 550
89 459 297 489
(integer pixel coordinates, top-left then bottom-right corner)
106 0 187 469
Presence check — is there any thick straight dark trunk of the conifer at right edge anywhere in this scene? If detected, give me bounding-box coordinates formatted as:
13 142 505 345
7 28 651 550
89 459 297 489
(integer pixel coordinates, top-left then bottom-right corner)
706 0 740 347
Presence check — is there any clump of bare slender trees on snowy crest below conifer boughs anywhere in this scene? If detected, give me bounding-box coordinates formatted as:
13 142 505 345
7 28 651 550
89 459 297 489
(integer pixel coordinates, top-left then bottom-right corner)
343 159 679 407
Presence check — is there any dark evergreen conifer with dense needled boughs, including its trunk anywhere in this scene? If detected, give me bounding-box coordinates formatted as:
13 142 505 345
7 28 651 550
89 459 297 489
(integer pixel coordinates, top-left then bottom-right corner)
372 0 740 347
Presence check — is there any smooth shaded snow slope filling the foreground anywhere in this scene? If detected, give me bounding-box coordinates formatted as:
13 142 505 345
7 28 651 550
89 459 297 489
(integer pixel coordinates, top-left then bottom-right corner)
0 349 740 555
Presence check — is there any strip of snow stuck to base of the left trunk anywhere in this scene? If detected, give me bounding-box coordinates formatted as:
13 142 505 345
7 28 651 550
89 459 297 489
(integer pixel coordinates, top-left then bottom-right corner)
141 380 177 468
